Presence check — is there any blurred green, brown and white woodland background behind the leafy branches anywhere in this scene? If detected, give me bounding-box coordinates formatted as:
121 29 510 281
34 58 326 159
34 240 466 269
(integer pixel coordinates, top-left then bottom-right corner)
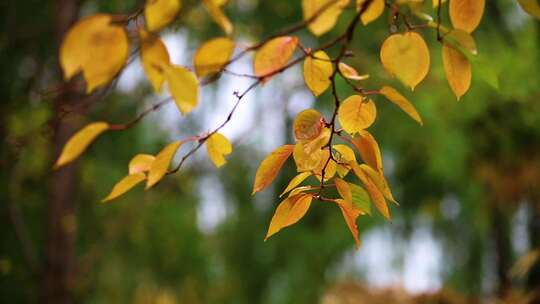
0 0 540 304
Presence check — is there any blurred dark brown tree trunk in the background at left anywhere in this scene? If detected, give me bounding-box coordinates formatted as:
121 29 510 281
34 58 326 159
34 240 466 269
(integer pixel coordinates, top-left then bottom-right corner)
41 0 79 304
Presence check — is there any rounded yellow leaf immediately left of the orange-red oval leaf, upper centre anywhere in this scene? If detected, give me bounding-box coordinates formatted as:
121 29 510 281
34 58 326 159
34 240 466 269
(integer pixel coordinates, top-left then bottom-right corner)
193 37 234 77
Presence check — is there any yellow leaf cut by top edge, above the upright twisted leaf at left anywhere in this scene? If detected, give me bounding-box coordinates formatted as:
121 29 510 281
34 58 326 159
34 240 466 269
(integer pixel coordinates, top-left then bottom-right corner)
144 0 182 32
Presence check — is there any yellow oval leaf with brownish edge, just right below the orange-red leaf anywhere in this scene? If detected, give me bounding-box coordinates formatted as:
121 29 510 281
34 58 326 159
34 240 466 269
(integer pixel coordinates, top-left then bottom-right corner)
304 51 334 96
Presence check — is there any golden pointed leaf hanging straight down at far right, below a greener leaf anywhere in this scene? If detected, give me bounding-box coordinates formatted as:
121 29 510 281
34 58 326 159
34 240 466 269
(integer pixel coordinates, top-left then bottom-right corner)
442 44 472 100
